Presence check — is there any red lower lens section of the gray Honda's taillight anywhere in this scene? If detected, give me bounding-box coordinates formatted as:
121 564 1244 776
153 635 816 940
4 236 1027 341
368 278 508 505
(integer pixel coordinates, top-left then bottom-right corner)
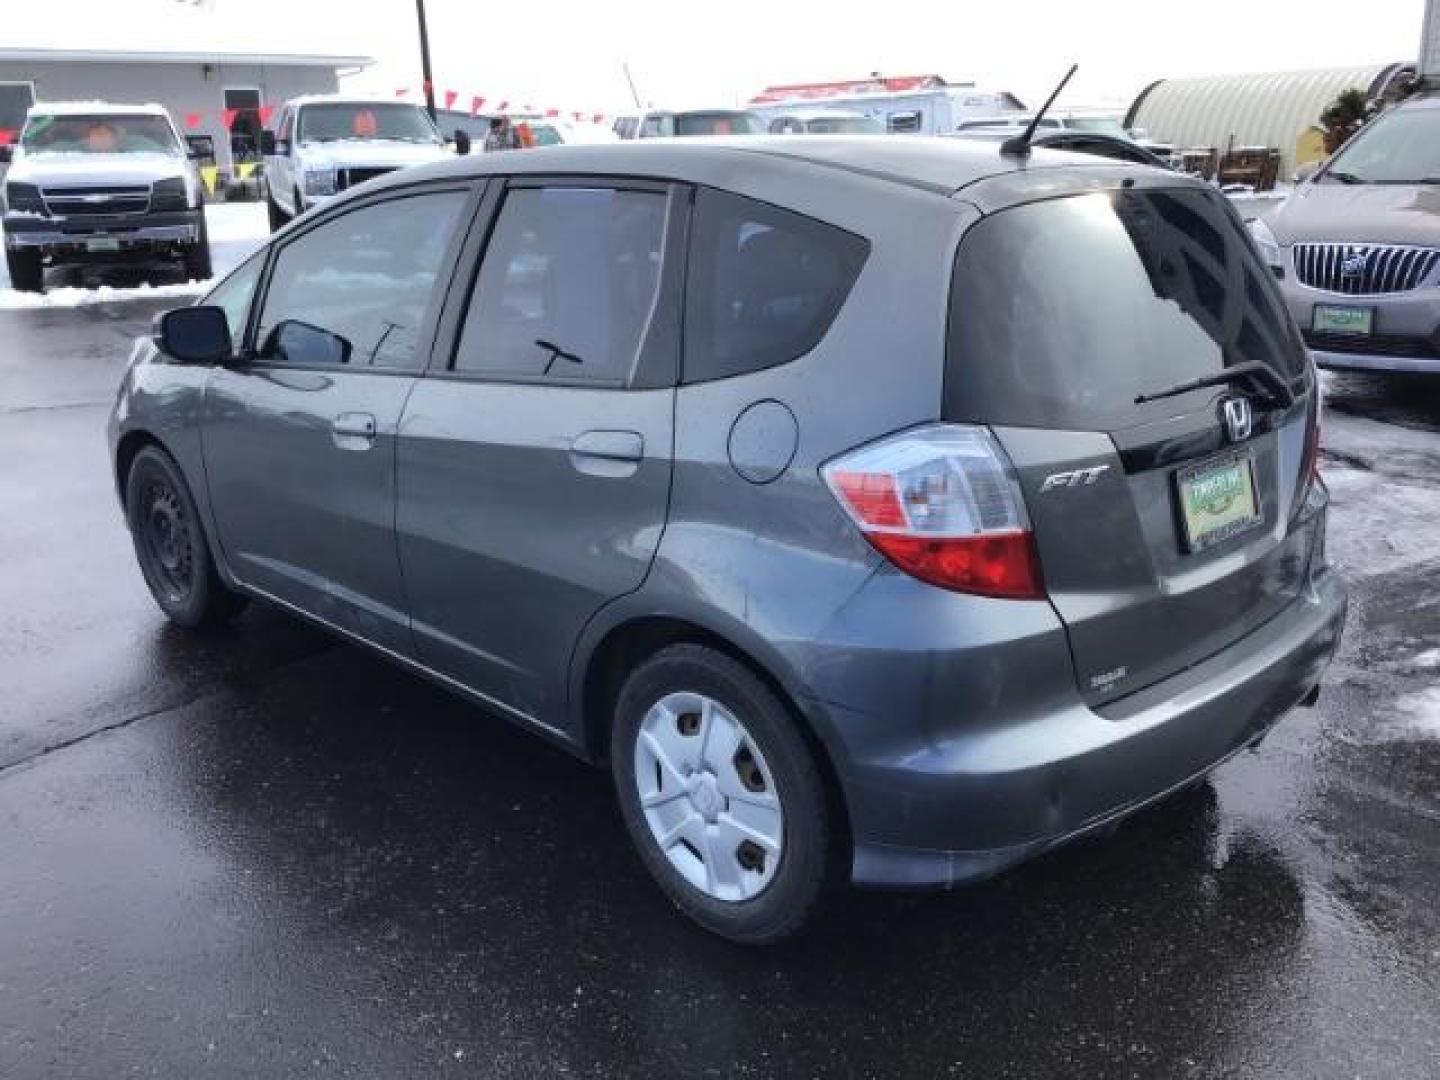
865 533 1045 600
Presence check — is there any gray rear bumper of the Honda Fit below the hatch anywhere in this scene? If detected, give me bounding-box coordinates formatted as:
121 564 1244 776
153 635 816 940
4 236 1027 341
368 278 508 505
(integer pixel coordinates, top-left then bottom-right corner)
823 541 1346 887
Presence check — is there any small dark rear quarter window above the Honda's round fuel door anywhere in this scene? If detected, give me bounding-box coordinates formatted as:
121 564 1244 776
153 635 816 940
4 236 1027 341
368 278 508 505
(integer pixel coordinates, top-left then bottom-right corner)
684 189 870 383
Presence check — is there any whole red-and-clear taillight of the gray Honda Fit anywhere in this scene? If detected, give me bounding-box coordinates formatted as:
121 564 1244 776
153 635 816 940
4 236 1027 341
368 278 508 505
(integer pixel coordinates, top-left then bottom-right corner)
822 425 1045 600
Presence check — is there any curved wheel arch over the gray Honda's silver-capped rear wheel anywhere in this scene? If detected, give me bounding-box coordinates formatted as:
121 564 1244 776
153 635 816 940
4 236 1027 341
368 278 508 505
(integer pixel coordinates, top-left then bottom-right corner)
582 616 851 851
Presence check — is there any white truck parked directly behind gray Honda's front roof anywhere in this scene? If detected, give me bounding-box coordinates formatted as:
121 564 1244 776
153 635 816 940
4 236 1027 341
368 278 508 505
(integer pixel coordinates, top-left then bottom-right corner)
261 94 471 232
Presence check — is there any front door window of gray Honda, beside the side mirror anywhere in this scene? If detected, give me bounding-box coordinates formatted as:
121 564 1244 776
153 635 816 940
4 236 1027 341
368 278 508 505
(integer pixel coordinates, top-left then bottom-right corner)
256 192 467 369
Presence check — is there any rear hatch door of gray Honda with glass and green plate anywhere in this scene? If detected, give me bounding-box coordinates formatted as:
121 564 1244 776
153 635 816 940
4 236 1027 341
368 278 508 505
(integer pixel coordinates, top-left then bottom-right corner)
945 186 1316 704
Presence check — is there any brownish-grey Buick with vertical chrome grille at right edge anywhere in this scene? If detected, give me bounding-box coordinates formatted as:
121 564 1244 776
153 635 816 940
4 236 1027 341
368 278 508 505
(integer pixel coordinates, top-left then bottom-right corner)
1251 96 1440 374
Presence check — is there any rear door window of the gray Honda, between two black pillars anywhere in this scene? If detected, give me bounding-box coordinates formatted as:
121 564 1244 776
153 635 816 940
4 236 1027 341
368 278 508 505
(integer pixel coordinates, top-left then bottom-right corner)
454 187 670 386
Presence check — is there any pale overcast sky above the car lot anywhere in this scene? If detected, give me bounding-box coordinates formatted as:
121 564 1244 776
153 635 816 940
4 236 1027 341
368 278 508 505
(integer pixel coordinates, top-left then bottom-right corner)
28 0 1424 112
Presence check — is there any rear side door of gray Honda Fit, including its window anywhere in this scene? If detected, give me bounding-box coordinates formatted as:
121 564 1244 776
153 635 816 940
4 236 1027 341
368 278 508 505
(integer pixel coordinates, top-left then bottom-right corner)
397 179 688 726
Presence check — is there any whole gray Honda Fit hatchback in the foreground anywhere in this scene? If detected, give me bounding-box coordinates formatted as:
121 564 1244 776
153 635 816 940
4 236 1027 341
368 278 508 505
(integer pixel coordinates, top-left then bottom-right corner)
109 137 1345 942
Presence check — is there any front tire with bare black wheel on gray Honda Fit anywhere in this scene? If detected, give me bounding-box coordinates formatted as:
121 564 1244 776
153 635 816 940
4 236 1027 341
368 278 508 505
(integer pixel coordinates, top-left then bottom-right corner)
125 446 246 628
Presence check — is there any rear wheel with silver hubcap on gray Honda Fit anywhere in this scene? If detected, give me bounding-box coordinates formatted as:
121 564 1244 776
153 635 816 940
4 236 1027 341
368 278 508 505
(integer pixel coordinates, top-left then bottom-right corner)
611 644 840 945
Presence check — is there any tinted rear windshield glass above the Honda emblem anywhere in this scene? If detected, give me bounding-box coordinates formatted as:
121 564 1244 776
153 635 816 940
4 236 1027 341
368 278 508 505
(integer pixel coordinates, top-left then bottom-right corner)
945 189 1305 431
